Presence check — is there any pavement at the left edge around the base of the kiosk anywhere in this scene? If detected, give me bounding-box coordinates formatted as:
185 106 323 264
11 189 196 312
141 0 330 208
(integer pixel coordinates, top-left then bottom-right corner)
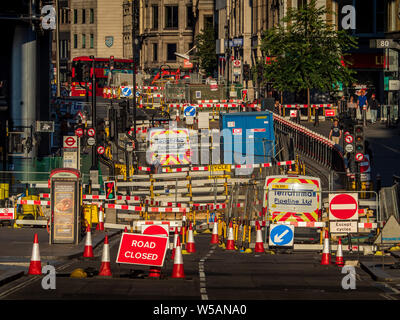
0 227 120 285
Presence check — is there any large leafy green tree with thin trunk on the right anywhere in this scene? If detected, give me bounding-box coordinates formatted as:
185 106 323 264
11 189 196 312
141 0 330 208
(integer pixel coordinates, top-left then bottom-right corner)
261 0 357 120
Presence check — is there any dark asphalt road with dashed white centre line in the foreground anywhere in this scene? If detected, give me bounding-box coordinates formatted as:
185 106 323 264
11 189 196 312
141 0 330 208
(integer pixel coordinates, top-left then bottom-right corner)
0 234 398 301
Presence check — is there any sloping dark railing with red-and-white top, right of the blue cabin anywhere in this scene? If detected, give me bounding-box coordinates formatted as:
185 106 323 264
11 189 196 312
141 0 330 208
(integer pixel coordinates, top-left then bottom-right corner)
274 113 346 172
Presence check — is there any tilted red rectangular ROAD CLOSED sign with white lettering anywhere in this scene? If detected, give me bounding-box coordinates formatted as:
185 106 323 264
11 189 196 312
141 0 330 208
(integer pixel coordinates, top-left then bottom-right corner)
116 233 168 267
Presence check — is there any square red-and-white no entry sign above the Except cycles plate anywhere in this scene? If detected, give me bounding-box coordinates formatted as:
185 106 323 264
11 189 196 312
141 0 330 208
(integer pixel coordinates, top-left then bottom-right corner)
329 193 358 220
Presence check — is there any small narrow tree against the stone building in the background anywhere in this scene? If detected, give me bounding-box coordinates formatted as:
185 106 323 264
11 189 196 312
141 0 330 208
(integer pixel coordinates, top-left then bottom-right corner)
195 24 217 76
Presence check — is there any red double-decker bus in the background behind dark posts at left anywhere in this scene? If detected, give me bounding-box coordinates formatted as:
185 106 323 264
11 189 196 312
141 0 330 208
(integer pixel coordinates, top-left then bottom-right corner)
71 56 133 97
